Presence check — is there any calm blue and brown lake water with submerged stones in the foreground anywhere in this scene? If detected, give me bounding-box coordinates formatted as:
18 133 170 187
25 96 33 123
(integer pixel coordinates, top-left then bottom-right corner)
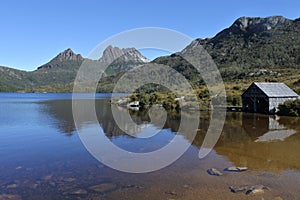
0 93 300 200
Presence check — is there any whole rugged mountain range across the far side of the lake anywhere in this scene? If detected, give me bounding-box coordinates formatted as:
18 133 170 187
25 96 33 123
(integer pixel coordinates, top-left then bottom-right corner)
0 16 300 91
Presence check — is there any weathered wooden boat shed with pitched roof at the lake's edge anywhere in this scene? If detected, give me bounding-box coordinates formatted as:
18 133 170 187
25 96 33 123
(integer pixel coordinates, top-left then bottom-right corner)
242 82 299 114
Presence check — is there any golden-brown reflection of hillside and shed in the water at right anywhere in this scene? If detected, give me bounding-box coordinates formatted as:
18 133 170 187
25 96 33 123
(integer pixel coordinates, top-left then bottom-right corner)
215 114 300 172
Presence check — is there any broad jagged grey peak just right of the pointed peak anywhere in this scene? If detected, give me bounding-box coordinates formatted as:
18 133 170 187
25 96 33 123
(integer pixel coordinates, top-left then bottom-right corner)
99 45 149 63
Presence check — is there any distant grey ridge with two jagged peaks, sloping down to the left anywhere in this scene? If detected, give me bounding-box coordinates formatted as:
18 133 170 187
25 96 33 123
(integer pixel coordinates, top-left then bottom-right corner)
0 46 148 91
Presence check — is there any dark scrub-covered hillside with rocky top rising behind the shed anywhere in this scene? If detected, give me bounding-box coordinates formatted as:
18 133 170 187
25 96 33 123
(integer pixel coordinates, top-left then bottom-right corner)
169 16 300 78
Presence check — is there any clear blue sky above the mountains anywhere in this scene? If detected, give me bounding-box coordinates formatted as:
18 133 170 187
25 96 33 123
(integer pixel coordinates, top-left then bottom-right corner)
0 0 300 70
